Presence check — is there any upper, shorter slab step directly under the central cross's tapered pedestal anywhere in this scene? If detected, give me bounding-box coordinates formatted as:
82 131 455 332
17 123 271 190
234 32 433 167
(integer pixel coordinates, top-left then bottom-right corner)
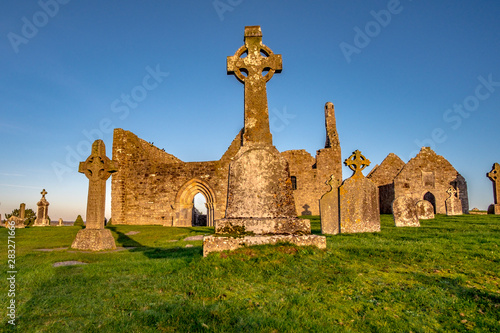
215 218 311 235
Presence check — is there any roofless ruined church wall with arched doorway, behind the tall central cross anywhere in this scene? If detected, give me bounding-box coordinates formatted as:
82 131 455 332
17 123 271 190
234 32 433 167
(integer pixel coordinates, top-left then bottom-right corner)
111 102 342 226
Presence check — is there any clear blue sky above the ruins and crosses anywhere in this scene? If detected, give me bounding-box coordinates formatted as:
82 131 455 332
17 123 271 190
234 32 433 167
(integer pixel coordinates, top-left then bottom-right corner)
0 0 500 221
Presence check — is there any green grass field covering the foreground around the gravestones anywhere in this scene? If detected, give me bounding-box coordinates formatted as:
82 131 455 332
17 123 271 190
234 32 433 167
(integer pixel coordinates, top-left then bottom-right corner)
0 215 500 332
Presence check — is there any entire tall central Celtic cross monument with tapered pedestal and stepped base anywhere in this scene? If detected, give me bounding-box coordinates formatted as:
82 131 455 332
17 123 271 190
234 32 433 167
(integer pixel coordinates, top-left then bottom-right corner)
203 26 326 256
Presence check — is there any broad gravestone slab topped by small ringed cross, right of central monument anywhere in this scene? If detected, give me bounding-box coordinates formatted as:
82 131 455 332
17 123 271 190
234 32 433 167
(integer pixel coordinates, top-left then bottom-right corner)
339 150 380 233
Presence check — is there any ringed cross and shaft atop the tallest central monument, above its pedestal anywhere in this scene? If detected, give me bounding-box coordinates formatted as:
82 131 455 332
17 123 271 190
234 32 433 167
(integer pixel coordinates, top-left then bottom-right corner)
227 26 282 145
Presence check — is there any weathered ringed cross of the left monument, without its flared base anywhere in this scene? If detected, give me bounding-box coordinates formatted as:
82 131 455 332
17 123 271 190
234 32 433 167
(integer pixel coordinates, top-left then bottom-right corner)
78 140 118 229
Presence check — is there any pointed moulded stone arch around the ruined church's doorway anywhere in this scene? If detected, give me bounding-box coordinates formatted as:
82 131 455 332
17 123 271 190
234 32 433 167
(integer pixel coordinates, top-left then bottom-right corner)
173 178 215 227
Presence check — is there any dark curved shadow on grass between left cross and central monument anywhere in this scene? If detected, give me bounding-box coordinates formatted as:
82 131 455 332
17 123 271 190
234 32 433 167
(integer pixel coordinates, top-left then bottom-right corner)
107 227 203 261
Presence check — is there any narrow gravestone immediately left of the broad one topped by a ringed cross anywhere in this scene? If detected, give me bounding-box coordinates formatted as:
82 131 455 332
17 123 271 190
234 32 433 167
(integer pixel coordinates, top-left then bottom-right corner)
319 175 340 235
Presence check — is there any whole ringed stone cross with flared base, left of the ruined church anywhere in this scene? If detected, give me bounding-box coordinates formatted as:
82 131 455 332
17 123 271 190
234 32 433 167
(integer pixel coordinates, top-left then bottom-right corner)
71 140 117 251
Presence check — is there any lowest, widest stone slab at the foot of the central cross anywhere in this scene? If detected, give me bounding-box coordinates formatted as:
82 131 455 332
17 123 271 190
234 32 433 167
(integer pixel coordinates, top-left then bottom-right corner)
203 235 326 257
